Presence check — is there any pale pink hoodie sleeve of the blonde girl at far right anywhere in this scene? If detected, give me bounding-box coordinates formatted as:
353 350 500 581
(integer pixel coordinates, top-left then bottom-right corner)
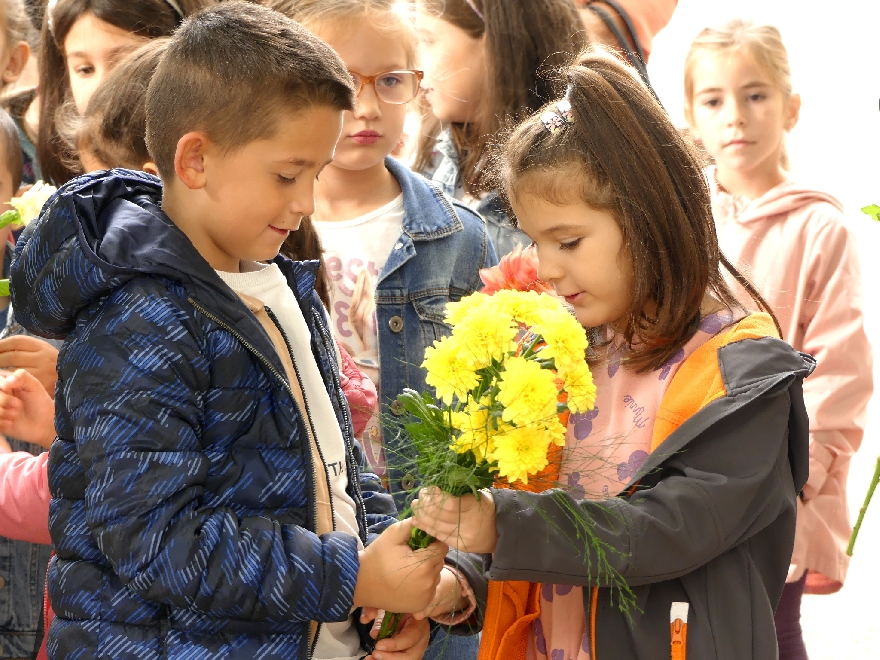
791 211 874 587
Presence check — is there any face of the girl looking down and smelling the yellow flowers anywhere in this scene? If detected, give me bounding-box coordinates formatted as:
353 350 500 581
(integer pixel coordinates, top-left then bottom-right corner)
510 188 633 327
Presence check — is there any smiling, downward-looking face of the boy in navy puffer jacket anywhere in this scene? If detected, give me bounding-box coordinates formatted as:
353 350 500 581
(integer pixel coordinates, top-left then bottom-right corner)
181 106 342 272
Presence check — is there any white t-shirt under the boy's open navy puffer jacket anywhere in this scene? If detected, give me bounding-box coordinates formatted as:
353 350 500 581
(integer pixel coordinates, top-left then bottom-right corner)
217 262 365 660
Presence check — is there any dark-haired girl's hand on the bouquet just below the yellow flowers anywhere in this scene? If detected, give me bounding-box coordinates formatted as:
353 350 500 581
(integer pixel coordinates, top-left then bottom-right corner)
412 488 498 553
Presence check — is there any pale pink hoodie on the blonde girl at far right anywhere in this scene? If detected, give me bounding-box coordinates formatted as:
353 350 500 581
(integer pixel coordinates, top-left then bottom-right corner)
707 168 874 593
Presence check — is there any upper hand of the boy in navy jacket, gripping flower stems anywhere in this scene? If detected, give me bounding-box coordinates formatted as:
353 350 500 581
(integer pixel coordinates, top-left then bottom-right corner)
354 520 448 613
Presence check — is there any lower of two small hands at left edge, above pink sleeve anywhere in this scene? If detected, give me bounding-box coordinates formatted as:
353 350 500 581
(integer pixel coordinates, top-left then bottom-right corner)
0 369 55 449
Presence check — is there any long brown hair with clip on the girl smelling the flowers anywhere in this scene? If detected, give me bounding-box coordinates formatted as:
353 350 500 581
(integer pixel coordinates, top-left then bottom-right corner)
497 51 779 371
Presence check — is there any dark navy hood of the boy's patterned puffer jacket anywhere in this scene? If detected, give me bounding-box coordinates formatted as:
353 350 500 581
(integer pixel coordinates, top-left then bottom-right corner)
10 169 314 339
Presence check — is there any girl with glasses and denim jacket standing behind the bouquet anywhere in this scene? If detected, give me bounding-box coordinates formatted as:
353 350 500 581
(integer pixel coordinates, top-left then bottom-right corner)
272 0 497 660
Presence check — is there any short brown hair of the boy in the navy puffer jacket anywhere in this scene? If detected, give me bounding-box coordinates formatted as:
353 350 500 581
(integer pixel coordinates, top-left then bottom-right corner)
147 1 355 181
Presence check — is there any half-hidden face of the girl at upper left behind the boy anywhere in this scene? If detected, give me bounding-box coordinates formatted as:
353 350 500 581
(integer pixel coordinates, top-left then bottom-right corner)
64 12 148 114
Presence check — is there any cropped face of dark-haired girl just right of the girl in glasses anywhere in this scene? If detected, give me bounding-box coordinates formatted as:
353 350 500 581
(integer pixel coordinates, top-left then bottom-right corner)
416 11 486 123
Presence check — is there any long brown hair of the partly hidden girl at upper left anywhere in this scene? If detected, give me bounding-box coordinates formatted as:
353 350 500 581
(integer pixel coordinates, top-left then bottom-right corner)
36 0 214 185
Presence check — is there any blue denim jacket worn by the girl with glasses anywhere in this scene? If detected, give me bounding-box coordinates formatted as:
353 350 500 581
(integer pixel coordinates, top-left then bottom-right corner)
376 158 498 506
